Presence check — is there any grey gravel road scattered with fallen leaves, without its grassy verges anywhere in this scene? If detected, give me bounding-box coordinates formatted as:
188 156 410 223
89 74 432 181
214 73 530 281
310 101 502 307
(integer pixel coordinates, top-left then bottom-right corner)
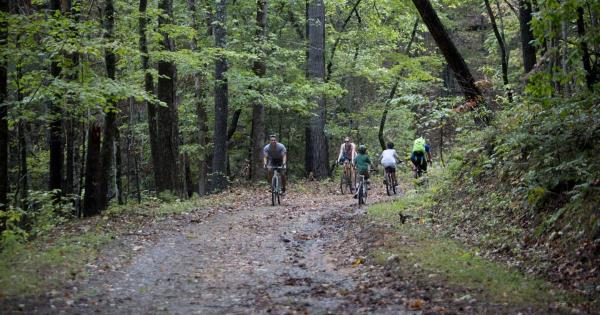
16 184 405 314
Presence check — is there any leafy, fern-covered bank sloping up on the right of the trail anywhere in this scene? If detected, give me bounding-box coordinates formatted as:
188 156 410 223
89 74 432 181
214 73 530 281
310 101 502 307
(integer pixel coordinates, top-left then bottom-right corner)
431 95 600 300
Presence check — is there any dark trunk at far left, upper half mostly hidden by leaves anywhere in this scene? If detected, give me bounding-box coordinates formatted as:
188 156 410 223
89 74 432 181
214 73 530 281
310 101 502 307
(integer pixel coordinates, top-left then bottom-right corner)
48 0 64 197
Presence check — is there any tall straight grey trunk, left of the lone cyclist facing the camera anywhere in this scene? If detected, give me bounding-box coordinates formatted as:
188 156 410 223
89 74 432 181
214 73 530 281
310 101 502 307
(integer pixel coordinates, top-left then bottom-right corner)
212 0 229 190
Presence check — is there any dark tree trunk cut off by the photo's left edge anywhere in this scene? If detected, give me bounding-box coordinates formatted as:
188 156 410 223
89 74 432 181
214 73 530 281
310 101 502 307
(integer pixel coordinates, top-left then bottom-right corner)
0 0 9 212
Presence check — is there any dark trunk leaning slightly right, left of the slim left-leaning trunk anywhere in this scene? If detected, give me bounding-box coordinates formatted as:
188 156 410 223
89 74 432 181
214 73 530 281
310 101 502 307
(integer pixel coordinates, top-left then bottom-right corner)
98 0 117 211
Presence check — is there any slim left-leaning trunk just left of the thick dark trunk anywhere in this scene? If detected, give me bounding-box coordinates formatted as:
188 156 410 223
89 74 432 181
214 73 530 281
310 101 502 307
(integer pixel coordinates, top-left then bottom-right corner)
138 0 162 190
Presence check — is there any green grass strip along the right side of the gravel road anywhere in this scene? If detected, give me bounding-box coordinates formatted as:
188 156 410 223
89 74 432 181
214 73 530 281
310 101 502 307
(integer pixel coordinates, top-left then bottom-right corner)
368 192 576 305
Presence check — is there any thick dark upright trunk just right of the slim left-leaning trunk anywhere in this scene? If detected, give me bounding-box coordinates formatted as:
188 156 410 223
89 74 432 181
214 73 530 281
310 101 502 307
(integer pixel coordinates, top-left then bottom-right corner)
154 0 182 193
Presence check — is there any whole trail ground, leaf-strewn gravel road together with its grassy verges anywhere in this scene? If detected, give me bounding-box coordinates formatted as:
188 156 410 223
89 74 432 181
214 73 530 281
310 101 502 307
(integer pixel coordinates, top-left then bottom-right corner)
0 182 586 314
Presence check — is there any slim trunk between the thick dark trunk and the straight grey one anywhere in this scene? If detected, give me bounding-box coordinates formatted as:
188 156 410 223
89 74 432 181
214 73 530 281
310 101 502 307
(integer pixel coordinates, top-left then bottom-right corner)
188 0 208 196
